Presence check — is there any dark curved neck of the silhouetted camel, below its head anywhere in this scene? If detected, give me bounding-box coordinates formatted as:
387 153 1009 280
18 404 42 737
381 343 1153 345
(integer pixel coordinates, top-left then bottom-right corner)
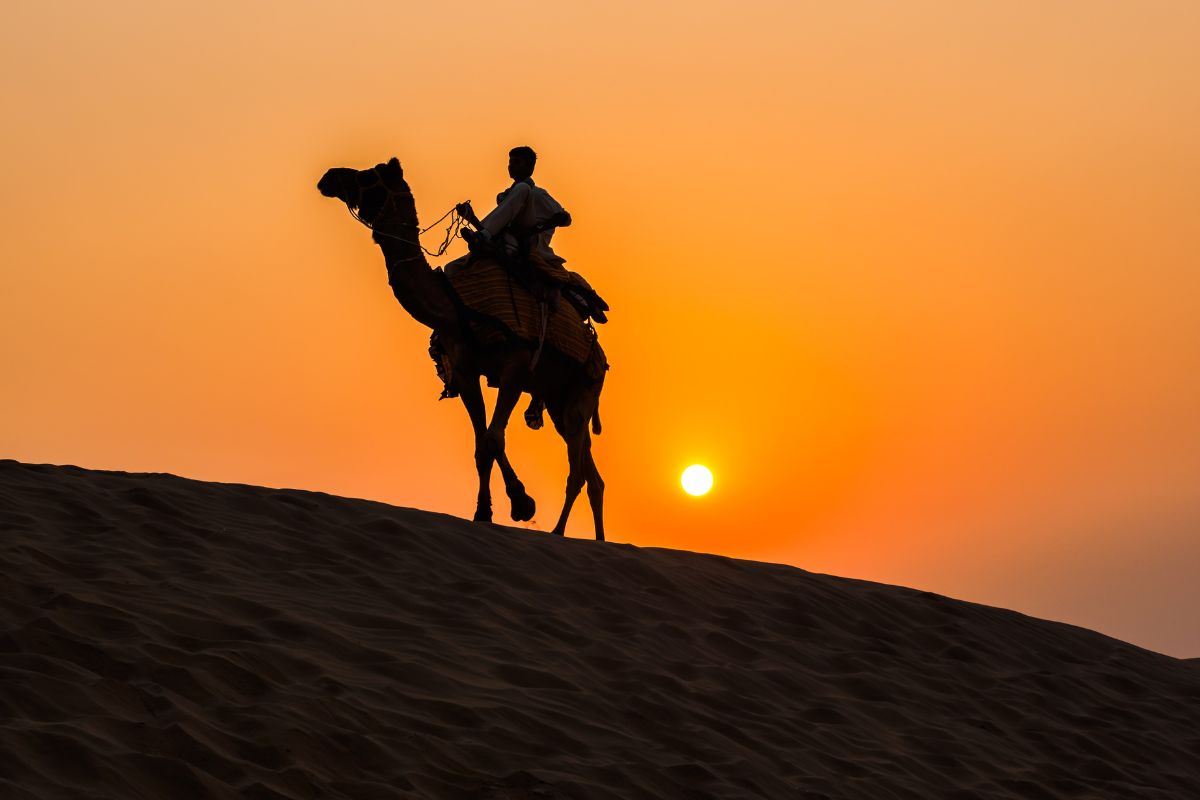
374 209 458 331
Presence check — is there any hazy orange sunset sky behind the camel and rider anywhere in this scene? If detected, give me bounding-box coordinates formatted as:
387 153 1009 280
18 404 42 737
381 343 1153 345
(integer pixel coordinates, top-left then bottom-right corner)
0 0 1200 656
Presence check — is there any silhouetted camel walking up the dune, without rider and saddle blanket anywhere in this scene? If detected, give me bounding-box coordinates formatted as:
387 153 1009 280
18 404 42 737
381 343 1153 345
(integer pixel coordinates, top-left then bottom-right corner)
317 158 604 541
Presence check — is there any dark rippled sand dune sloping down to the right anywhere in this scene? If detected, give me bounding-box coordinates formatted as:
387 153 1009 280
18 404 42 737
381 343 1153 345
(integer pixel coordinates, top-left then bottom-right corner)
0 461 1200 800
